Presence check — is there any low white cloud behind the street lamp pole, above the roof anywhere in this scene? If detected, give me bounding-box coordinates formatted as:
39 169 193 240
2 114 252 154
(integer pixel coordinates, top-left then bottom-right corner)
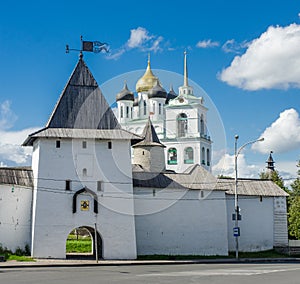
212 153 262 178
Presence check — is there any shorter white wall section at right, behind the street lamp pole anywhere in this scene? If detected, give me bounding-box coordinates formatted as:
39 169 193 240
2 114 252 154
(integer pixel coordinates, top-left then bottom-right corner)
226 195 274 252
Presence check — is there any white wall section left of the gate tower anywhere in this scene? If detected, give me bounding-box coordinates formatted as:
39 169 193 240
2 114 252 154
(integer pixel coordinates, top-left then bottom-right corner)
0 184 32 252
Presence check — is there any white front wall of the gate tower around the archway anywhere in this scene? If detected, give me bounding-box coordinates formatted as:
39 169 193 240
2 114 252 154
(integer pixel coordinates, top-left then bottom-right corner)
32 139 136 259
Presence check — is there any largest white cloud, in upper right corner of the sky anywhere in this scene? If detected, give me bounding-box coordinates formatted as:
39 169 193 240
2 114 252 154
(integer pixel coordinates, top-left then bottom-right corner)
219 24 300 90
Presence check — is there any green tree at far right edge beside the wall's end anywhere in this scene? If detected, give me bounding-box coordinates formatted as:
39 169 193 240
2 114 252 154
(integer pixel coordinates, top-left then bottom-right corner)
288 160 300 240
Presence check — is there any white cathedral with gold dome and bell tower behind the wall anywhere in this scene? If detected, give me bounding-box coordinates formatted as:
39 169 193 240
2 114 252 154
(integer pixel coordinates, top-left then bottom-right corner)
116 52 212 173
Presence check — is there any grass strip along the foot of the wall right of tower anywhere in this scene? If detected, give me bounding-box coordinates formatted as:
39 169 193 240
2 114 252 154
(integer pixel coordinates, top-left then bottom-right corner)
138 250 288 260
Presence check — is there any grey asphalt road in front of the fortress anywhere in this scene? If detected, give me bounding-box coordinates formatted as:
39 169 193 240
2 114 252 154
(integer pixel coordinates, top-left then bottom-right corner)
0 263 300 284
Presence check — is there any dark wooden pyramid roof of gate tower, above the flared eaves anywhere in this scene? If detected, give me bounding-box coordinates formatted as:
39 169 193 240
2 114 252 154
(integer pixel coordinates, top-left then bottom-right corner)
46 56 121 129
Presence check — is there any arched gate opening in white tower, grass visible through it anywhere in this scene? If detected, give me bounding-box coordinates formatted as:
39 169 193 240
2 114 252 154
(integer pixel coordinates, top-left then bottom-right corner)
66 226 103 259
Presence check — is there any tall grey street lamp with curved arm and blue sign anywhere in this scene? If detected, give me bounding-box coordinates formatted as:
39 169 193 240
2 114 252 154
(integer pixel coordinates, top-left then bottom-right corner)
233 135 264 259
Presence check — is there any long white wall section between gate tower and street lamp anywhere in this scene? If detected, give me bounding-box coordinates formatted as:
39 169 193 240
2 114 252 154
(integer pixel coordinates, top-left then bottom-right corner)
134 188 228 255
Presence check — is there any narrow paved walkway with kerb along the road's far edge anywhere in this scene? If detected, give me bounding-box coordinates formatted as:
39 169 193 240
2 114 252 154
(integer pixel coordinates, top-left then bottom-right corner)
0 258 300 269
